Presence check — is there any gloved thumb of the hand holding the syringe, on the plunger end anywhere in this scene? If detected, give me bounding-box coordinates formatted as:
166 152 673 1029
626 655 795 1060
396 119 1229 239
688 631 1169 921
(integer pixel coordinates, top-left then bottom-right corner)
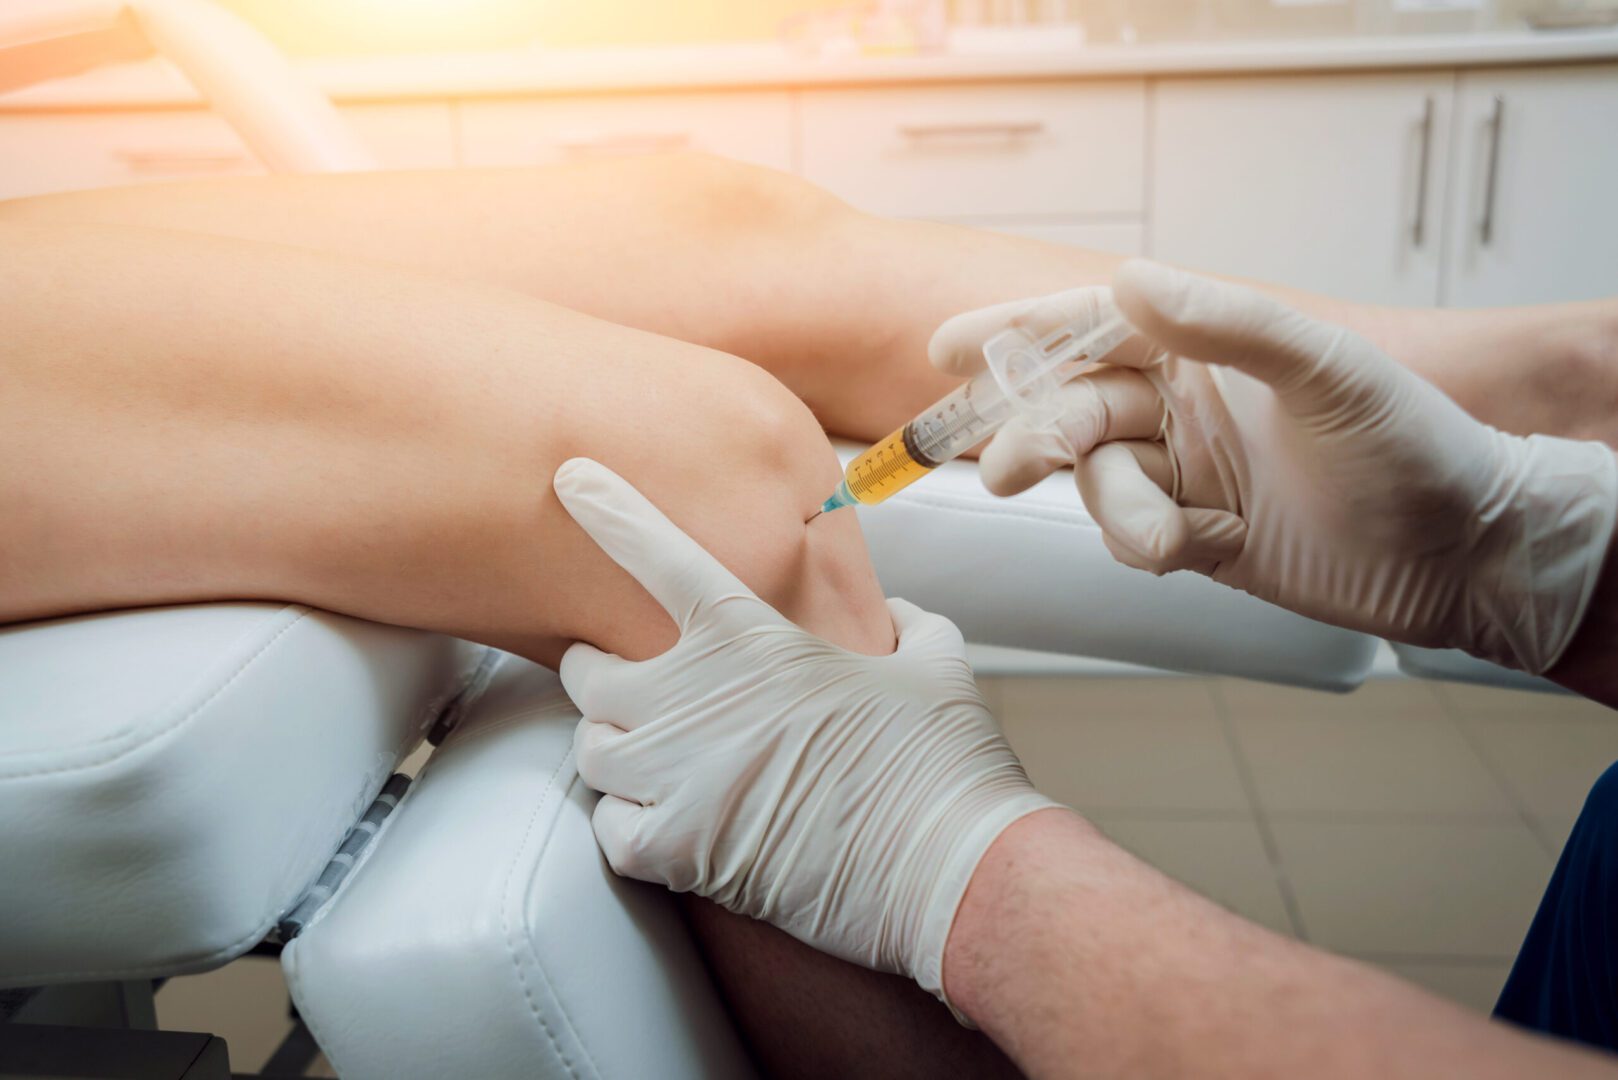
1113 259 1365 416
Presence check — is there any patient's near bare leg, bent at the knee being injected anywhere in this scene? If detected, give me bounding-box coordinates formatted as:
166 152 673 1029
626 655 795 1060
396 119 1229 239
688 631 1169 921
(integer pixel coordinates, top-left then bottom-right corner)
0 216 1003 1075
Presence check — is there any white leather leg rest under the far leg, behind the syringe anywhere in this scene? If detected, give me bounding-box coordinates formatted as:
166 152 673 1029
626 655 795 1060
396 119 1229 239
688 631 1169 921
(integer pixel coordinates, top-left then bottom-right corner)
838 445 1377 690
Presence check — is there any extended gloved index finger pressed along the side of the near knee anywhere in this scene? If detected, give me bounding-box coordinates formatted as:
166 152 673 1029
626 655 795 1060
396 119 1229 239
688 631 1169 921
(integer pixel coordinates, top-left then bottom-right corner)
552 458 757 633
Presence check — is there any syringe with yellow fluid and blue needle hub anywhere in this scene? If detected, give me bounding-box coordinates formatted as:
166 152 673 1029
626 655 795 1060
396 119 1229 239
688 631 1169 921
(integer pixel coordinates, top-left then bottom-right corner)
815 298 1134 517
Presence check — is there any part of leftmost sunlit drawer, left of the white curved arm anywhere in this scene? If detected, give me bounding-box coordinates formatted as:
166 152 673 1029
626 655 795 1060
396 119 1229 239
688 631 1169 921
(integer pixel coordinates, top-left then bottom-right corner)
0 110 264 198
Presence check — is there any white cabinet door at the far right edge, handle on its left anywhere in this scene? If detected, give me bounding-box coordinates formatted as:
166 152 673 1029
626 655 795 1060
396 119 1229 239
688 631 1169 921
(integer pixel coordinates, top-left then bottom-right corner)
1445 65 1618 306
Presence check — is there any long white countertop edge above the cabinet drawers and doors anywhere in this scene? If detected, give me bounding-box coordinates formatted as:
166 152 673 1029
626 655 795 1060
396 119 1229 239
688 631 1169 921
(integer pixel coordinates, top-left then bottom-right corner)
0 29 1618 110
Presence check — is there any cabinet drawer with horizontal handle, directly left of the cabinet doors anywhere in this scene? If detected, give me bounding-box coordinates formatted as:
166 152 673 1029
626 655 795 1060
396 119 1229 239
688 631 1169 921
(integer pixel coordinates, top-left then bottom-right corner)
801 79 1146 217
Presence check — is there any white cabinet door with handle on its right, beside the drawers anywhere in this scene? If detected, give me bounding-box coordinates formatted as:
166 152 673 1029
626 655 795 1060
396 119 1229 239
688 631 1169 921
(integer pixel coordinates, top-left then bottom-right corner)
1147 73 1455 306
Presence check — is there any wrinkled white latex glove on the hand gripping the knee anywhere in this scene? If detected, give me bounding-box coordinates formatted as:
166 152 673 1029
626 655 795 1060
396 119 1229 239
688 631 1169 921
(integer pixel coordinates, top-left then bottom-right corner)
555 458 1053 997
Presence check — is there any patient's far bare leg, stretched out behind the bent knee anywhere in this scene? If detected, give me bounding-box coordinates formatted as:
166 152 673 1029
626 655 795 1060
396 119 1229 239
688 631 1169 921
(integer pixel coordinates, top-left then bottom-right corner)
0 154 1618 444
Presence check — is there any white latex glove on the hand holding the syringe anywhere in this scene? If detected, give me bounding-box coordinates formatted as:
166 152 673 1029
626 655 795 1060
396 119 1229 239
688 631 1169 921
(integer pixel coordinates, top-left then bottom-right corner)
932 261 1618 674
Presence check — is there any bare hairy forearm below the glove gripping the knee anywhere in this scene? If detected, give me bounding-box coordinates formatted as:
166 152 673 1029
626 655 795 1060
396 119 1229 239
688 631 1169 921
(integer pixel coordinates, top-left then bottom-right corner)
943 811 1618 1080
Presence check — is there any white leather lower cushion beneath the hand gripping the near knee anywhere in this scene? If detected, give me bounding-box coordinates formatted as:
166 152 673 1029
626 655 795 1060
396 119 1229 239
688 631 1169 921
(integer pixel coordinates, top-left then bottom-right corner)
282 657 749 1080
